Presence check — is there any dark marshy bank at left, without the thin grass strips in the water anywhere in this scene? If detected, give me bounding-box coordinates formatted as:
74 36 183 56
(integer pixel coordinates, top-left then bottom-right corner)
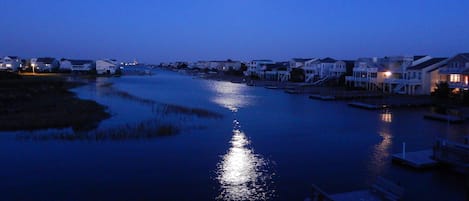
0 73 110 131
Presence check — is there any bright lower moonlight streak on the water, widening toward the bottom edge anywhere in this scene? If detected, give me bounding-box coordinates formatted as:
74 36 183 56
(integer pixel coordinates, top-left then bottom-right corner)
217 120 273 200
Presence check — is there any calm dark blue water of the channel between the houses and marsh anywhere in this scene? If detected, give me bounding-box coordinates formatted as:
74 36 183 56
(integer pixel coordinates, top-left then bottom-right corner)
0 71 468 200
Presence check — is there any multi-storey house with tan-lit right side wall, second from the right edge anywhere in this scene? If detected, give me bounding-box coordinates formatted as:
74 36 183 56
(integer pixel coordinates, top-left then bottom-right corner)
404 58 448 95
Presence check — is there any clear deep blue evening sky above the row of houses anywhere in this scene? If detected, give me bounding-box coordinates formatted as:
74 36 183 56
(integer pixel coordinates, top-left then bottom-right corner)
0 0 469 63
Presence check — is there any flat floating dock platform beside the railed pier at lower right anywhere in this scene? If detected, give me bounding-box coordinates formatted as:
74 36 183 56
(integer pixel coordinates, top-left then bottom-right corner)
392 149 438 169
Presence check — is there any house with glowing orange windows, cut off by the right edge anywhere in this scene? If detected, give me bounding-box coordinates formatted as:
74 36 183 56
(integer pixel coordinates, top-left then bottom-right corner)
439 53 469 91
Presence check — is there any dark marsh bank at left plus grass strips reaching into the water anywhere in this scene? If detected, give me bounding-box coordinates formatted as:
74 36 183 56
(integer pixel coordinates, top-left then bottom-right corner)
0 73 223 141
